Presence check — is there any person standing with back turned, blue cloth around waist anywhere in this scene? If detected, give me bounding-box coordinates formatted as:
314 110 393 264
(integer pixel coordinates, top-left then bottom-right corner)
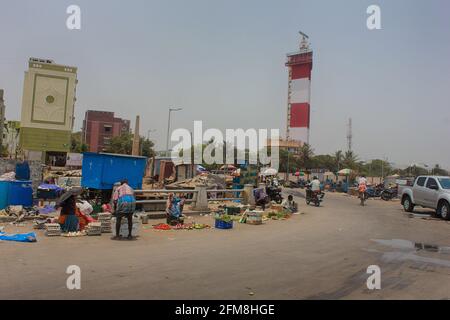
112 179 136 240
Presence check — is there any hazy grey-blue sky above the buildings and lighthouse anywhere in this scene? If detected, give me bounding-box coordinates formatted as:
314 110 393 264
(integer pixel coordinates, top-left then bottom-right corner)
0 0 450 168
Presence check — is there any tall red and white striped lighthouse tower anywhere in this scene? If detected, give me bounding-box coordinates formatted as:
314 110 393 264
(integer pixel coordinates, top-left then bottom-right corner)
286 32 313 143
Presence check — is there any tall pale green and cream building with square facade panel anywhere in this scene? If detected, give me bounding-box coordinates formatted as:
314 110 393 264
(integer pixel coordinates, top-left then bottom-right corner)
20 58 78 165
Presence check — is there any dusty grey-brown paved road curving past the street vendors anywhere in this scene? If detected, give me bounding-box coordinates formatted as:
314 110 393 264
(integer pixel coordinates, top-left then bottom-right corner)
0 190 450 299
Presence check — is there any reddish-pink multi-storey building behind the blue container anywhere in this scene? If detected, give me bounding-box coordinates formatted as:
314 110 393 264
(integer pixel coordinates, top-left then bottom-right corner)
82 110 130 152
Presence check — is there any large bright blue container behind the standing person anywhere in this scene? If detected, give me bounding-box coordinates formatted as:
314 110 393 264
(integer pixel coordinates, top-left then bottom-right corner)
81 152 147 190
